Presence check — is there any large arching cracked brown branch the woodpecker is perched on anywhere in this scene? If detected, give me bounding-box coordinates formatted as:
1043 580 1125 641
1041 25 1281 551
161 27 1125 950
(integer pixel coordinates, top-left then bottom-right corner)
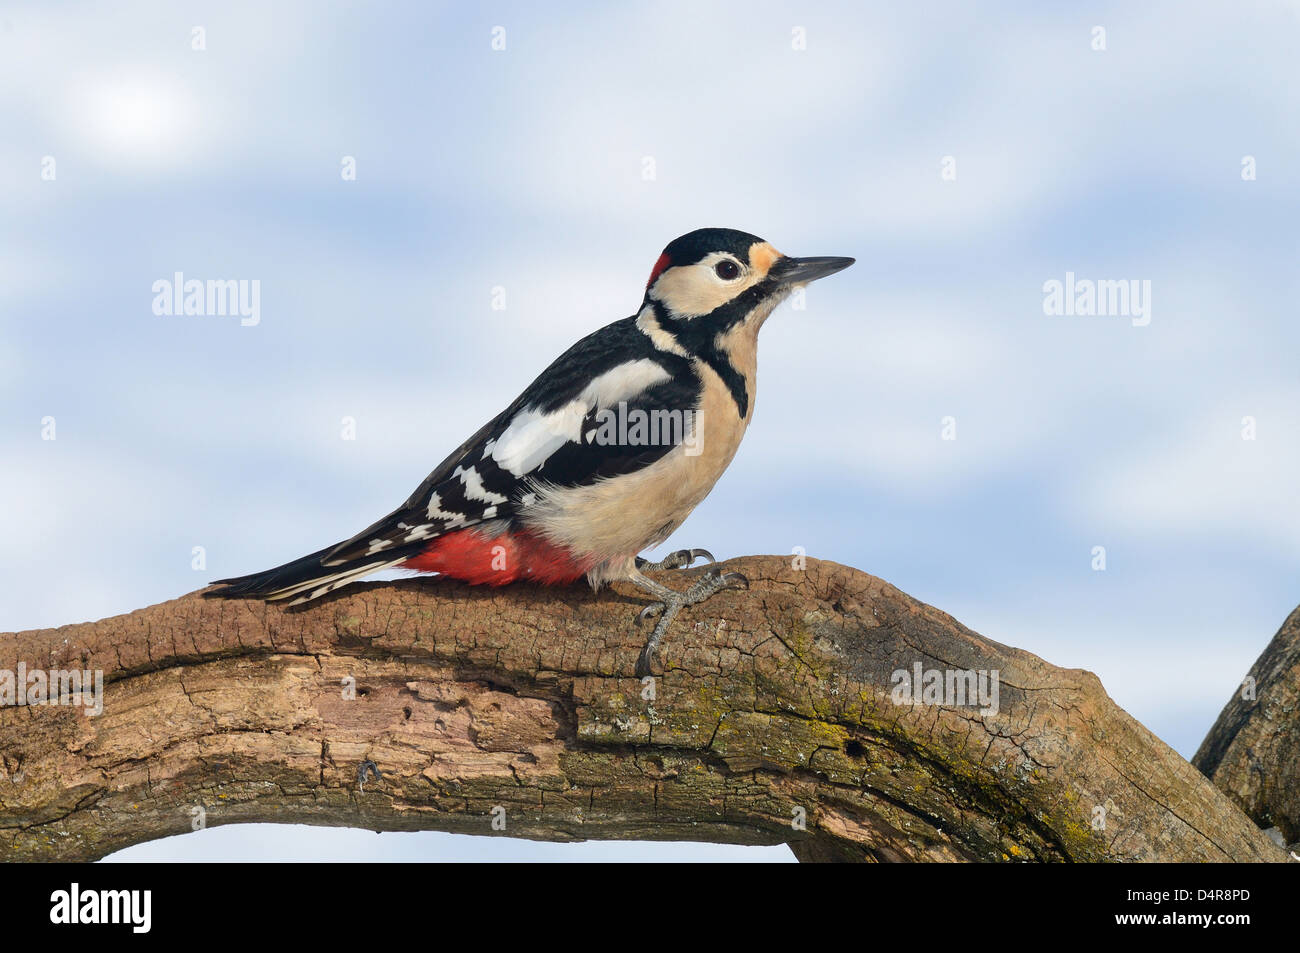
0 556 1294 861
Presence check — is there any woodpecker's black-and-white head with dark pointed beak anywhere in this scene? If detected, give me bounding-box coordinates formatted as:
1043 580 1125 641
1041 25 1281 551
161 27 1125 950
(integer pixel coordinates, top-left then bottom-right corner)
645 229 853 334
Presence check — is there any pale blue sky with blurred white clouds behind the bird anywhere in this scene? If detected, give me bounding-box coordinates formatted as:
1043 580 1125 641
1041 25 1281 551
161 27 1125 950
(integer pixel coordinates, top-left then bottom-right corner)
0 3 1300 859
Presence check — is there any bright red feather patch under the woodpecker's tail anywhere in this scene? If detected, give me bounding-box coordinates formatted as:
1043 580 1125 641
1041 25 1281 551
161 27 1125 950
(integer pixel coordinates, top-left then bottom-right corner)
400 529 594 585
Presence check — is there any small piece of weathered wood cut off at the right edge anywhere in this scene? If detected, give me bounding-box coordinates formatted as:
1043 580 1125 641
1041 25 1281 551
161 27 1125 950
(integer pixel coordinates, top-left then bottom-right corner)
1192 608 1300 844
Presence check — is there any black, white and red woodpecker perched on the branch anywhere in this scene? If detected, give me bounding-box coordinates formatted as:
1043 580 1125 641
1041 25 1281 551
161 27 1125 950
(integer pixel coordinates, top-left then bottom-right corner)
205 229 854 676
